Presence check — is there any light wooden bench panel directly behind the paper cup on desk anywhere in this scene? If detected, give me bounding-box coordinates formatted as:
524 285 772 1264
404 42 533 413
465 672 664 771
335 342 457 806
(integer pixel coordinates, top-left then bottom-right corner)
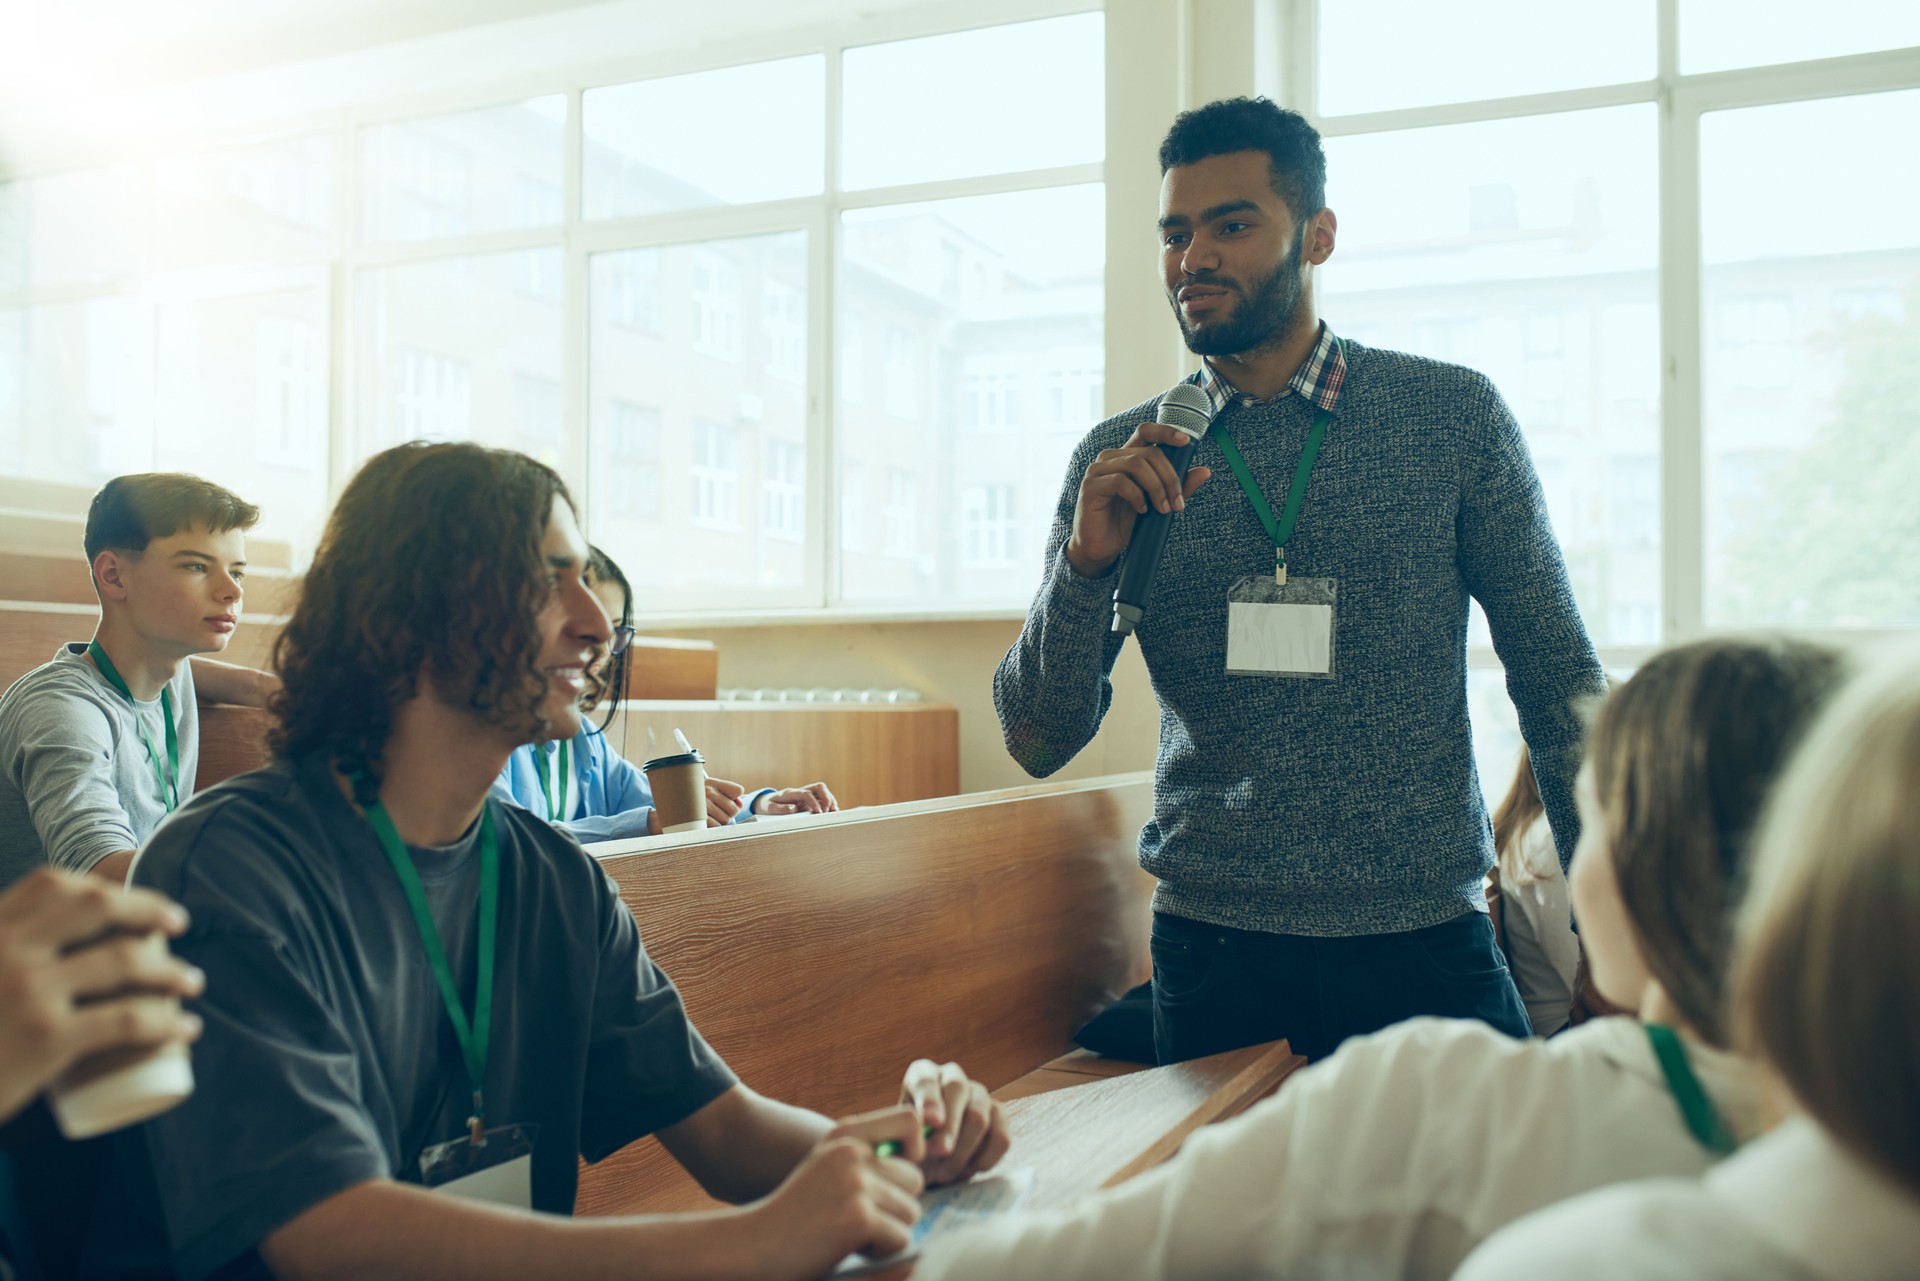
611 701 960 807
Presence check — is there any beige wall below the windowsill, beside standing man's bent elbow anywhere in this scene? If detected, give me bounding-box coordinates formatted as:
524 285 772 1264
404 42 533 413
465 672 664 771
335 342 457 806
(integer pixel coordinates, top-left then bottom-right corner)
645 618 1160 791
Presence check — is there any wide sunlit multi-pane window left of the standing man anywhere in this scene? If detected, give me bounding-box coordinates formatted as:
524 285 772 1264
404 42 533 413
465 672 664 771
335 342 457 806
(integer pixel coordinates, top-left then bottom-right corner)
0 10 1106 613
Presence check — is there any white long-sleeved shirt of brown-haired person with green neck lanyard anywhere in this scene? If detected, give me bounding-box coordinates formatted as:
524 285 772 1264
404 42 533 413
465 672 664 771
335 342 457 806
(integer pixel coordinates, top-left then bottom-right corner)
914 1018 1753 1281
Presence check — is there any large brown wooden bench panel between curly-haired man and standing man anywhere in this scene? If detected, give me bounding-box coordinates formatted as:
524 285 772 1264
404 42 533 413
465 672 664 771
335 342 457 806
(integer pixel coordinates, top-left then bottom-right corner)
580 774 1154 1214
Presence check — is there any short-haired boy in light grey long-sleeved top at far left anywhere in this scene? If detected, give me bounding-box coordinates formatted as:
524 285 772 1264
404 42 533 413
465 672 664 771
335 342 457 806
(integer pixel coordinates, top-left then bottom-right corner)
0 472 276 887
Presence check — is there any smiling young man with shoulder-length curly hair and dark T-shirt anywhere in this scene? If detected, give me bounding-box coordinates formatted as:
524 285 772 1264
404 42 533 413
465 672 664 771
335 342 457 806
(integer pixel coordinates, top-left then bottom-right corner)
90 444 1006 1281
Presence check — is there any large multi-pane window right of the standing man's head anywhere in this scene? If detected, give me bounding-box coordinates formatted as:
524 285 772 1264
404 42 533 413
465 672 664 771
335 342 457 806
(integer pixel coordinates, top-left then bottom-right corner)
1294 0 1920 801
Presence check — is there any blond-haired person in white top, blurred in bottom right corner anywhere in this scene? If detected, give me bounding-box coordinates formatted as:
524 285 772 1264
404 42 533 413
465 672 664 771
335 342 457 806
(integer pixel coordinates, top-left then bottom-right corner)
1459 661 1920 1281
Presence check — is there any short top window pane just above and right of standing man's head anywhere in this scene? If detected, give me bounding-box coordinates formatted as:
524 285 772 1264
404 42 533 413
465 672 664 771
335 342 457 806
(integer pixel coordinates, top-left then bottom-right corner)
1319 0 1658 115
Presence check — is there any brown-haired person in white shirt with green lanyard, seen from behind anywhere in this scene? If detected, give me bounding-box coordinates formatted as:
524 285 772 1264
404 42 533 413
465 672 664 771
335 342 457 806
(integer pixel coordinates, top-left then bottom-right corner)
914 640 1841 1281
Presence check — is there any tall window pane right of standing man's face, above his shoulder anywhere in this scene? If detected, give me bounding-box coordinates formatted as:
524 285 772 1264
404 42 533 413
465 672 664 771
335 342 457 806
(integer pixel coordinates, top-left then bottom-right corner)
1321 106 1661 643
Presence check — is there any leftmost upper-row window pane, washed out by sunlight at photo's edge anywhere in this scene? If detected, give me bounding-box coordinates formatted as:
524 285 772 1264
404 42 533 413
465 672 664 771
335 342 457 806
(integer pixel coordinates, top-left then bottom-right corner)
0 163 148 290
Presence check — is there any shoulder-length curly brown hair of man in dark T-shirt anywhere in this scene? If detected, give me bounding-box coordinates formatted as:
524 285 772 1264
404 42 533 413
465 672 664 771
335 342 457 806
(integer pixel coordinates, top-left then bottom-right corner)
267 440 574 778
